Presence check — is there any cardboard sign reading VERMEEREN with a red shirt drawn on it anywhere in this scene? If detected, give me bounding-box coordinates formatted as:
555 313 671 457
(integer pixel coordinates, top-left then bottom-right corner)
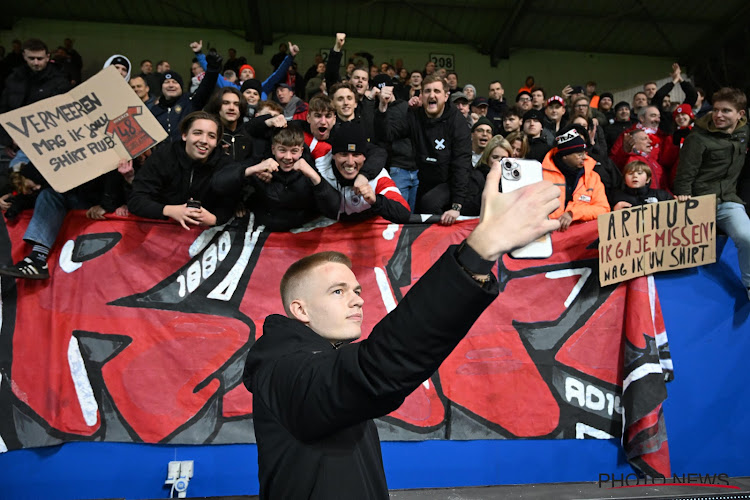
0 66 167 193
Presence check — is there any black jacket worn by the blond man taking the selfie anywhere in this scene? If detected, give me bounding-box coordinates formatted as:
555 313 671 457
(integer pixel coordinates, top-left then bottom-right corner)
243 246 499 500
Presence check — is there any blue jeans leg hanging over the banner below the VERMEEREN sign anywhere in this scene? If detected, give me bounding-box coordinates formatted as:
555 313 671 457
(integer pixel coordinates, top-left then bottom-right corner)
23 188 91 248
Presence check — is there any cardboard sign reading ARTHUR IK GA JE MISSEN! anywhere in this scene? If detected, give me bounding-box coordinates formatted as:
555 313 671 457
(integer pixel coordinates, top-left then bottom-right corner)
597 195 716 286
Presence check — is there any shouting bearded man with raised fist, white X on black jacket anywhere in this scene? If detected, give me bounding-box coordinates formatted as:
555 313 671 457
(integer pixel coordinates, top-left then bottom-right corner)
375 76 471 225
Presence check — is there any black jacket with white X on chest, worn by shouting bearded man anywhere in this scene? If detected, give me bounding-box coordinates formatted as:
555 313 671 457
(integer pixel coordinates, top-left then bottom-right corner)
375 102 471 205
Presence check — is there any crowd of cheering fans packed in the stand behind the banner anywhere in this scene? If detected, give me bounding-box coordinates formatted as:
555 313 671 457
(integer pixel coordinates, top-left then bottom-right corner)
0 33 750 298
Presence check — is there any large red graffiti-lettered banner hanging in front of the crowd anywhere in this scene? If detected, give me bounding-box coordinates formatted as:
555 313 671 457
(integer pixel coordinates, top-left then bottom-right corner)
0 212 672 476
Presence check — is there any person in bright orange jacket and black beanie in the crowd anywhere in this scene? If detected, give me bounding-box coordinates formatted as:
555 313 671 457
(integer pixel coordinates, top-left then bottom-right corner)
542 125 609 231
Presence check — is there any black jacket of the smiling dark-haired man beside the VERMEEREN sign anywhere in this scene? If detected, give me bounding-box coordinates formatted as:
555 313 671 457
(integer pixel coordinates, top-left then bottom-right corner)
128 141 240 225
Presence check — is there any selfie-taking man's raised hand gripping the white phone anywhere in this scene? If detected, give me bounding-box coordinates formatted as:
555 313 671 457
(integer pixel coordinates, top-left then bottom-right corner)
466 162 560 261
